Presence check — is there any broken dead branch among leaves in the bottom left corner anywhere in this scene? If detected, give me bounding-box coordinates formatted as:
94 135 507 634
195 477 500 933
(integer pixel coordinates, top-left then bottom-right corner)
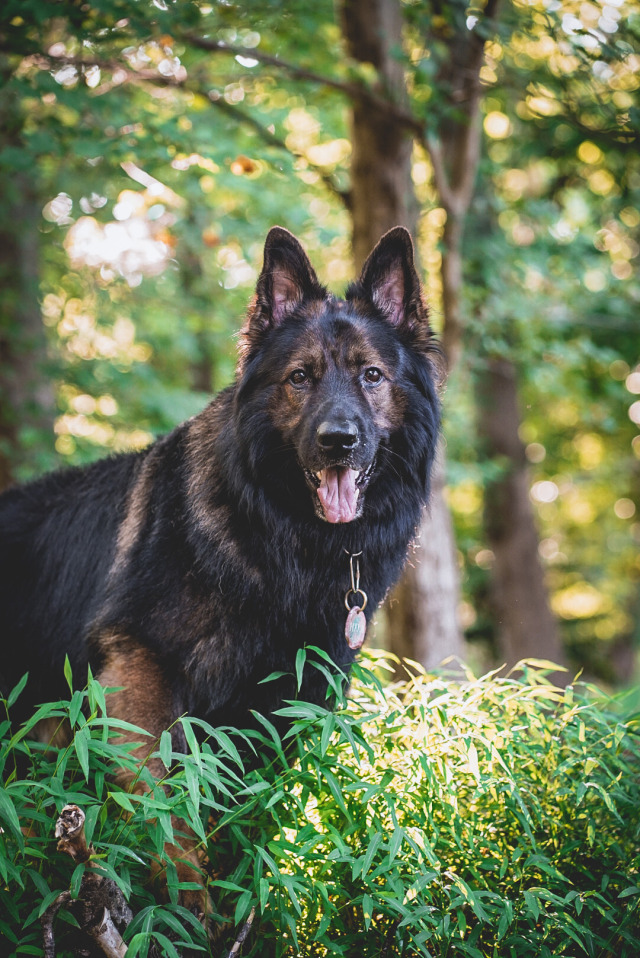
40 805 133 958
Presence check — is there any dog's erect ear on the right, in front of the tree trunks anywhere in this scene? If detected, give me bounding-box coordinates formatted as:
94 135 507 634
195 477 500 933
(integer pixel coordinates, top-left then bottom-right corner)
347 226 428 331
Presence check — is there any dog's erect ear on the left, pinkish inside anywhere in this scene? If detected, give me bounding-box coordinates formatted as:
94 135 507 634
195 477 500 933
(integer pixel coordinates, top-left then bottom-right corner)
249 226 325 330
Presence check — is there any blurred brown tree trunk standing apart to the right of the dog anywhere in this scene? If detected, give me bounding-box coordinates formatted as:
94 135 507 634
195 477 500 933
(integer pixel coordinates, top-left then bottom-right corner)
477 359 566 682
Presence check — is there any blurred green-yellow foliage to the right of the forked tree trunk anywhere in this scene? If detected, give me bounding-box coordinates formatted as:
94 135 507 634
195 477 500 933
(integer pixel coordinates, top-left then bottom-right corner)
430 2 640 683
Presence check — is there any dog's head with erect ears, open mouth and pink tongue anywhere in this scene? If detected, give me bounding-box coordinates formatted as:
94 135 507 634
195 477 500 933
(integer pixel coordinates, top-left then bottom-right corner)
239 227 434 523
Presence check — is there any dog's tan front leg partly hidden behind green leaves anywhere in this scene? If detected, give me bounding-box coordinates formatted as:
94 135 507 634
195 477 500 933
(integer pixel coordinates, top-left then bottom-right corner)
98 636 212 922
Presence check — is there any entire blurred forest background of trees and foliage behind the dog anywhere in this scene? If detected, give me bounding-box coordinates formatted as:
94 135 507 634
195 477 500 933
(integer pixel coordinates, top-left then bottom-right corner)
0 0 640 685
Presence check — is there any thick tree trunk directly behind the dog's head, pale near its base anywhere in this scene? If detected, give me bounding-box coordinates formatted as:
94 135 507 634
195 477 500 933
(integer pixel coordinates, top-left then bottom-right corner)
342 0 463 668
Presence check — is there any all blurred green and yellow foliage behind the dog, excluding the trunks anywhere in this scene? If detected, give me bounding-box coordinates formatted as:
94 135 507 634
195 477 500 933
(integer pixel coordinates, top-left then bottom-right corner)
0 0 640 683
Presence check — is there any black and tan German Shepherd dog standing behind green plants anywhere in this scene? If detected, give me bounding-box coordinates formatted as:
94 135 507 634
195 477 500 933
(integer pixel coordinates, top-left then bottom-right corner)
0 227 439 924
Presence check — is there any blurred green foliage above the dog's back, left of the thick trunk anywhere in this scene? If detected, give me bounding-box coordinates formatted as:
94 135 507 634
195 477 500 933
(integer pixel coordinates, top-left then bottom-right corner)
0 0 348 480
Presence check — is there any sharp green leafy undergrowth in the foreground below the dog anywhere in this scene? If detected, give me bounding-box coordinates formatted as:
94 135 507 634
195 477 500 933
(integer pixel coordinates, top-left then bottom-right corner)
0 649 640 958
